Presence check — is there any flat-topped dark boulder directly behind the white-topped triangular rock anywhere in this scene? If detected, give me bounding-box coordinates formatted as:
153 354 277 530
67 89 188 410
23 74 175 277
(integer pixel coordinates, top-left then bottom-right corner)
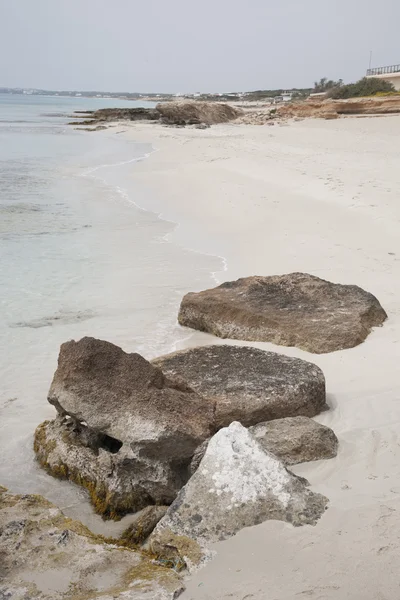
152 345 326 428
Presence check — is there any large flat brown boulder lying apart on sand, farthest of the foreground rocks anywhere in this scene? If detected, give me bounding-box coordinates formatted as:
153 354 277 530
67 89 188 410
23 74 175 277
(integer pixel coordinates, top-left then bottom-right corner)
178 273 387 354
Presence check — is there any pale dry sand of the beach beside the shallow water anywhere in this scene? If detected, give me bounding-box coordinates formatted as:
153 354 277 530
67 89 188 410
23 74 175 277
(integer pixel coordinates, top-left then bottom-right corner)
120 117 400 600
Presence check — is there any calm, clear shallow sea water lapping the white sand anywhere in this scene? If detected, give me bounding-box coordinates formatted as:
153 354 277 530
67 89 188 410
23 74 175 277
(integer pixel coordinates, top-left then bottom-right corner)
0 95 221 533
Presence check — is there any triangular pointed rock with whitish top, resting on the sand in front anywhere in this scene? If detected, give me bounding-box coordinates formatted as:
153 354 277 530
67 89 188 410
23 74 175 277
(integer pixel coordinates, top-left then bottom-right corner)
149 423 328 553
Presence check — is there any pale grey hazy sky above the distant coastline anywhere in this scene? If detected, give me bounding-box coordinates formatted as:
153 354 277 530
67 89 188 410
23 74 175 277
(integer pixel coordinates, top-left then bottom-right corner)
0 0 400 93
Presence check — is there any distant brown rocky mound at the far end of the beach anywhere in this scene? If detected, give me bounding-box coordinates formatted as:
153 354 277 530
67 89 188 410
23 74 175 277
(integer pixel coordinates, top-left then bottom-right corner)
156 101 243 125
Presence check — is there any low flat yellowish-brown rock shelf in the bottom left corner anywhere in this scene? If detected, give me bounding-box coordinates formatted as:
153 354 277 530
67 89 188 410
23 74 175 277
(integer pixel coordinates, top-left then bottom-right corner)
0 488 183 600
